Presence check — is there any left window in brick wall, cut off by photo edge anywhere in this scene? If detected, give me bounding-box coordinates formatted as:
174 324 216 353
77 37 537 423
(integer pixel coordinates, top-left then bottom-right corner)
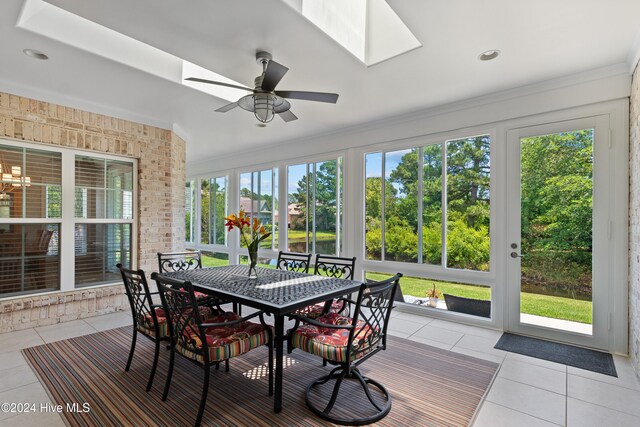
0 145 62 297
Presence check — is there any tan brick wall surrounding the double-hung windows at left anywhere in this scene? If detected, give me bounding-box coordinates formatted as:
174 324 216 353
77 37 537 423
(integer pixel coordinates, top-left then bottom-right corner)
0 92 185 332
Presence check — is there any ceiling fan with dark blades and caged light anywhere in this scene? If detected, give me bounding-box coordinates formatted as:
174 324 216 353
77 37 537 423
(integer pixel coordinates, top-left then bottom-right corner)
186 52 338 123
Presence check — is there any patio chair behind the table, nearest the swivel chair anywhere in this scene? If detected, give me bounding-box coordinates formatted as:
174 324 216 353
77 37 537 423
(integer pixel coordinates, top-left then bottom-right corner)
296 254 356 319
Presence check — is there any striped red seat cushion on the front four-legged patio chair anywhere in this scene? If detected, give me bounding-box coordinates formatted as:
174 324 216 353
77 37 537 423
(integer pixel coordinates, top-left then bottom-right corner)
176 312 269 363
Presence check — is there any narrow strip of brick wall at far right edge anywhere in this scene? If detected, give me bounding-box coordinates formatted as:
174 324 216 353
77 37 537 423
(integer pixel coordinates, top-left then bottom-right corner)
629 63 640 376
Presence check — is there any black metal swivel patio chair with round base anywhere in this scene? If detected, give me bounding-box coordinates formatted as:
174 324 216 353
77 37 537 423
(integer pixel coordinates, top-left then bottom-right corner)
287 273 402 425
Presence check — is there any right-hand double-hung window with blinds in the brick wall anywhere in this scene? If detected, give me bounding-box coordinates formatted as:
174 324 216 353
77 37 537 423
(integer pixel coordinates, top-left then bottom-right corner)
74 155 133 287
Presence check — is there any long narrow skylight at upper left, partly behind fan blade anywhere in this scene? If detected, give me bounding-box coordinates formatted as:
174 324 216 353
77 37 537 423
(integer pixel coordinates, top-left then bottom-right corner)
16 0 247 102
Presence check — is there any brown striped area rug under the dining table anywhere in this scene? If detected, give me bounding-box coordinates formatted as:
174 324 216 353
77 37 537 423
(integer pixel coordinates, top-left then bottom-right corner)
23 327 498 426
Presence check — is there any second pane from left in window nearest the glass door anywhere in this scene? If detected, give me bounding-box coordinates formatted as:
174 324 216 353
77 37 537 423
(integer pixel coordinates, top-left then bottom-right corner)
384 148 418 262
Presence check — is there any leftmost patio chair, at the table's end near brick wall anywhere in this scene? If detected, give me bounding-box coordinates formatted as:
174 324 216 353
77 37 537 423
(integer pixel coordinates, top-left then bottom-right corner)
117 264 169 391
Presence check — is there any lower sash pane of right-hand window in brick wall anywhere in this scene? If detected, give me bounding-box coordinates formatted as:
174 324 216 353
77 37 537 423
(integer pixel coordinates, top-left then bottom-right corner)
75 224 131 286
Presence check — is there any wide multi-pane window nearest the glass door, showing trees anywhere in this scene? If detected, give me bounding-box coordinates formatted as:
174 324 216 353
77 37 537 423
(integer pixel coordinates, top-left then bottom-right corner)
365 135 490 271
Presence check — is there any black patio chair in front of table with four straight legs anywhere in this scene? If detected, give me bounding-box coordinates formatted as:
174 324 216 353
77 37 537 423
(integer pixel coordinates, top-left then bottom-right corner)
151 273 273 426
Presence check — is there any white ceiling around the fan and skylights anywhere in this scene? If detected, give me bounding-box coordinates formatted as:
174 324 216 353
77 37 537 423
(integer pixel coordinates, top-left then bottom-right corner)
0 0 640 168
